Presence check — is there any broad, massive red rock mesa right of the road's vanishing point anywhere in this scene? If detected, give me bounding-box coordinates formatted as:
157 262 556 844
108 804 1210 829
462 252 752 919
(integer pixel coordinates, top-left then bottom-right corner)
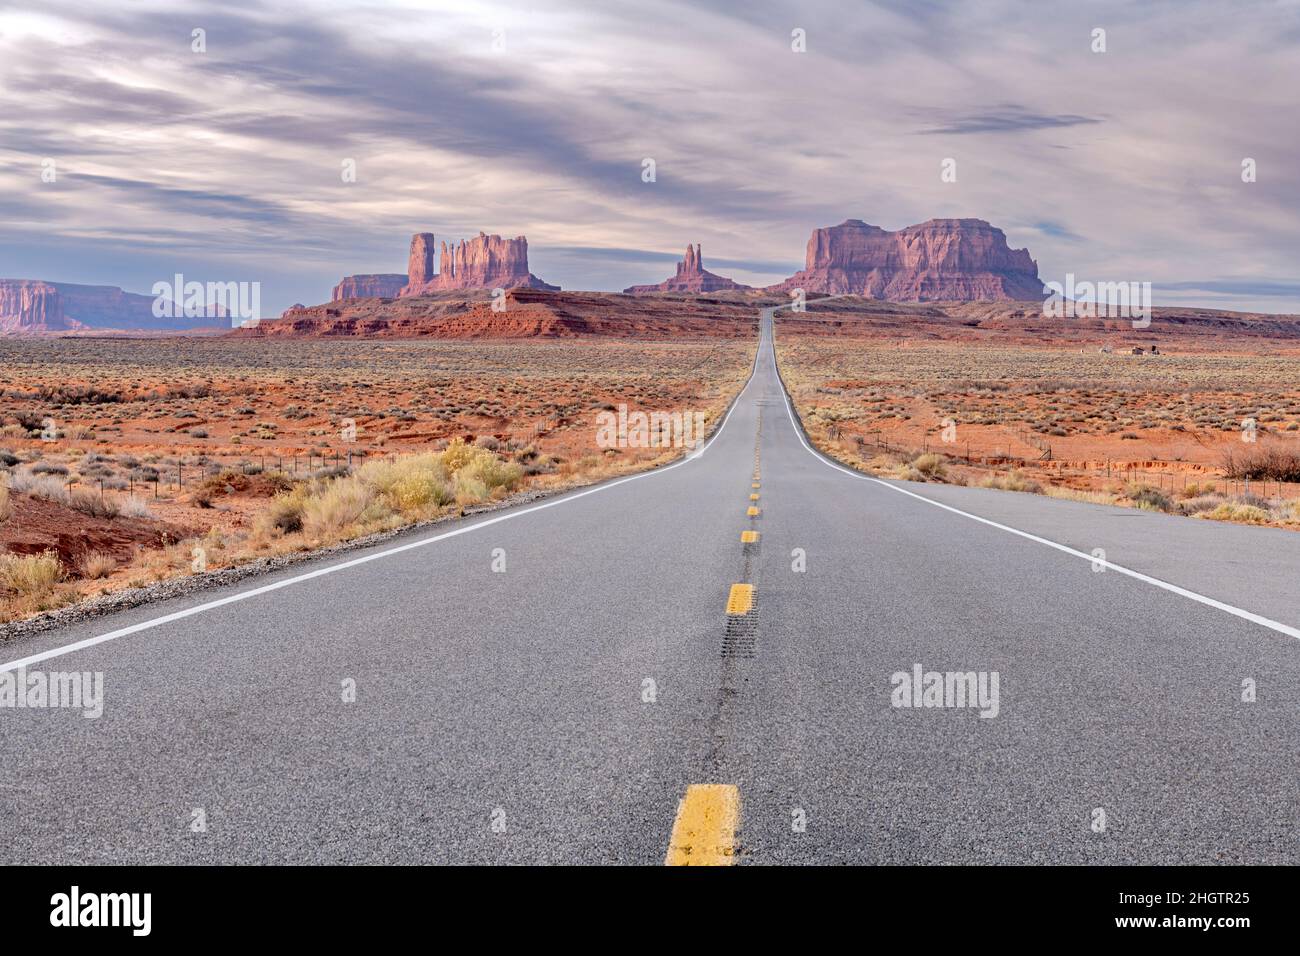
770 219 1043 302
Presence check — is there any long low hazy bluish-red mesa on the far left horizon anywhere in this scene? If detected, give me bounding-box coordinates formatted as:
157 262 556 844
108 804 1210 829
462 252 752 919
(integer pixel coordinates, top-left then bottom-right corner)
0 278 224 334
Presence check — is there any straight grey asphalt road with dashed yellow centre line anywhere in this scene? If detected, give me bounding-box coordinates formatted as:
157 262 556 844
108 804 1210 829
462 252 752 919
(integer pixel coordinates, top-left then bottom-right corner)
0 313 1300 864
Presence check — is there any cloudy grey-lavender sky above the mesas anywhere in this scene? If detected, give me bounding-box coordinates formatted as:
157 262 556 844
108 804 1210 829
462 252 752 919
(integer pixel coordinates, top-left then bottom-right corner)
0 0 1300 313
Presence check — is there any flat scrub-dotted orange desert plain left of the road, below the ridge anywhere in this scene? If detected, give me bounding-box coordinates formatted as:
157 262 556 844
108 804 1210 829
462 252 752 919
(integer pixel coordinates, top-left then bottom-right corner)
0 326 754 619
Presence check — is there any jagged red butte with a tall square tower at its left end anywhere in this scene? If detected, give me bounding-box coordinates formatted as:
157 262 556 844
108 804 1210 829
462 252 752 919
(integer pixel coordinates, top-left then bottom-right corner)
399 233 559 295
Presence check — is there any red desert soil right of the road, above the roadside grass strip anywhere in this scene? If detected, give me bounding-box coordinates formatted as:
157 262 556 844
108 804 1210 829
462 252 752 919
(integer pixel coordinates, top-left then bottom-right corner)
776 298 1300 509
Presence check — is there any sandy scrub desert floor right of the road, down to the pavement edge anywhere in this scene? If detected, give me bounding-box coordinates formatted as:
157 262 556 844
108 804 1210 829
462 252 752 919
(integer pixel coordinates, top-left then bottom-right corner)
777 306 1300 525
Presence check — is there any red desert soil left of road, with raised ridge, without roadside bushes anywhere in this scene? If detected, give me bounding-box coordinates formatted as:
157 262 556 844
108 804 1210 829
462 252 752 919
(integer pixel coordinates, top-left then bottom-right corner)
0 299 758 620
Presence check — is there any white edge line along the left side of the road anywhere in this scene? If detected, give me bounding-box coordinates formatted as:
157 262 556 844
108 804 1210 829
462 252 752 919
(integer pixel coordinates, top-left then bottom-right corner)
0 329 763 674
